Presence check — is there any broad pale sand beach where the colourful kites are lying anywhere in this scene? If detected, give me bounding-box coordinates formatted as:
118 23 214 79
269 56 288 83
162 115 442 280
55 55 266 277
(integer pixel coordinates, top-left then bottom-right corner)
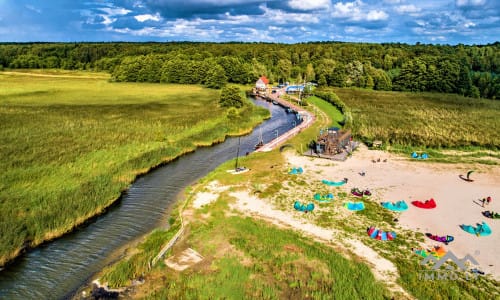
288 147 500 280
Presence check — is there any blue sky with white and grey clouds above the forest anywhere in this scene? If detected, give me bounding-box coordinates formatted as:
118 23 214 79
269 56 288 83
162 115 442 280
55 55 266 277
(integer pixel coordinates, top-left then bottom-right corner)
0 0 500 44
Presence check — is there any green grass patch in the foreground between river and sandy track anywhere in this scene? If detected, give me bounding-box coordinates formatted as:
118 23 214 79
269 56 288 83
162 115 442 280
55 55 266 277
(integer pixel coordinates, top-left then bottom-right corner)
143 206 389 299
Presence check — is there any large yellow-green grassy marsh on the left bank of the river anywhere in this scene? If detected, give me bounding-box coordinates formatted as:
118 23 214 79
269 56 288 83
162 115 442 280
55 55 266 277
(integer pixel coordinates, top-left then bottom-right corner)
0 71 268 266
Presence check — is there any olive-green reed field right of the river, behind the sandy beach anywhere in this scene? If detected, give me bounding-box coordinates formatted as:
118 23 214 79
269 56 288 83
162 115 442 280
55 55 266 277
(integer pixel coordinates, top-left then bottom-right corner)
326 88 500 150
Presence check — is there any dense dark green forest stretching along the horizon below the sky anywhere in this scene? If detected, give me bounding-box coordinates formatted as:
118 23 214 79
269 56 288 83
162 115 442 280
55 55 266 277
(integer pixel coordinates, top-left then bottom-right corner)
0 42 500 99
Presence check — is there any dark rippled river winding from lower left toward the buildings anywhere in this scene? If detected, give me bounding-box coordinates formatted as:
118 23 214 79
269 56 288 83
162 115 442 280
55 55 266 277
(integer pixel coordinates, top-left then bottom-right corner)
0 100 298 299
